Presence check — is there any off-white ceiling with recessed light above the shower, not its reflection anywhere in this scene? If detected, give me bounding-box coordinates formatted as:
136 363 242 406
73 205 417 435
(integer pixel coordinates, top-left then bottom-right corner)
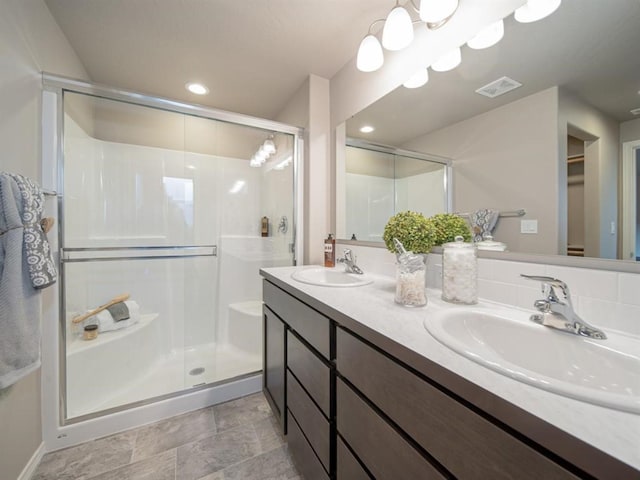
45 0 394 118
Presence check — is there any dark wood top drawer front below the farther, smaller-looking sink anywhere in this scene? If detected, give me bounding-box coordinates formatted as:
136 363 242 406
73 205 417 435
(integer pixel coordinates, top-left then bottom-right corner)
262 280 331 359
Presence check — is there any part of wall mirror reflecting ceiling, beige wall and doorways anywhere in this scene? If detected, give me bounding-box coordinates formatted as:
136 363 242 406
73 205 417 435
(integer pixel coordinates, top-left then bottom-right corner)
336 0 640 260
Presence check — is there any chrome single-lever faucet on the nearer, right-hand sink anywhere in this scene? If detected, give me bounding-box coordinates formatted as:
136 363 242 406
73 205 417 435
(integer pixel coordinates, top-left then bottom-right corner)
520 274 607 340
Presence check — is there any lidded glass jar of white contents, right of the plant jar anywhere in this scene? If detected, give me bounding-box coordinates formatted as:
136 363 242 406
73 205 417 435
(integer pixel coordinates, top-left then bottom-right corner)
442 236 478 305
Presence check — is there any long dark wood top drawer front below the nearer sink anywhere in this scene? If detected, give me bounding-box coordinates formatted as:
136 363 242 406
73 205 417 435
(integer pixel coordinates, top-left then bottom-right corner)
336 328 576 480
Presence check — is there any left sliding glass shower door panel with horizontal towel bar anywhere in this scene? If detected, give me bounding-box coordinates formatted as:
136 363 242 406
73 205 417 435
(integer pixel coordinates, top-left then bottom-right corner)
61 92 217 418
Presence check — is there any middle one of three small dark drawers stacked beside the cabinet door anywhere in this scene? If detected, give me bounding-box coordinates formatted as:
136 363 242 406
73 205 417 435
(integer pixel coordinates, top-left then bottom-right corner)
287 371 331 471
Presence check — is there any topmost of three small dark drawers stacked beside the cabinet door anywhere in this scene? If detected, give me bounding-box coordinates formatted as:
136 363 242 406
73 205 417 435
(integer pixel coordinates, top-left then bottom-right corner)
287 331 331 418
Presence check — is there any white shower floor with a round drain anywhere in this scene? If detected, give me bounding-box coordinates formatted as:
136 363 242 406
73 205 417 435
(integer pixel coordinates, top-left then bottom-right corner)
67 343 262 419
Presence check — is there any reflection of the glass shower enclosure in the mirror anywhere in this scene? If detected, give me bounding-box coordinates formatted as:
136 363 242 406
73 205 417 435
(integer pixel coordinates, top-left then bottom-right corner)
337 140 451 242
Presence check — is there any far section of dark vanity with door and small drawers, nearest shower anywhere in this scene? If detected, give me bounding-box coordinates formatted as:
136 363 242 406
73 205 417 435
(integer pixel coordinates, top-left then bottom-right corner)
263 281 335 480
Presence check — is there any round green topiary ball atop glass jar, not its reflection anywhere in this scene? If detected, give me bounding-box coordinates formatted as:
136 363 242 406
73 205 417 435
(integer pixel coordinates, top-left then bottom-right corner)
382 211 436 254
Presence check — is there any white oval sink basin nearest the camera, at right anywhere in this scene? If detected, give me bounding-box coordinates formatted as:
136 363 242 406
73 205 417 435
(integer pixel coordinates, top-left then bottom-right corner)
424 307 640 414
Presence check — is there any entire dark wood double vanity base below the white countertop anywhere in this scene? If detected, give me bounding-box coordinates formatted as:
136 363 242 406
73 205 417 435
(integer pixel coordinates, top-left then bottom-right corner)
263 272 640 480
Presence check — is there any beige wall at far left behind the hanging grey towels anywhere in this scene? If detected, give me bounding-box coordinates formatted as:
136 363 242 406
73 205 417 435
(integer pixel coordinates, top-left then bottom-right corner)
0 0 86 480
